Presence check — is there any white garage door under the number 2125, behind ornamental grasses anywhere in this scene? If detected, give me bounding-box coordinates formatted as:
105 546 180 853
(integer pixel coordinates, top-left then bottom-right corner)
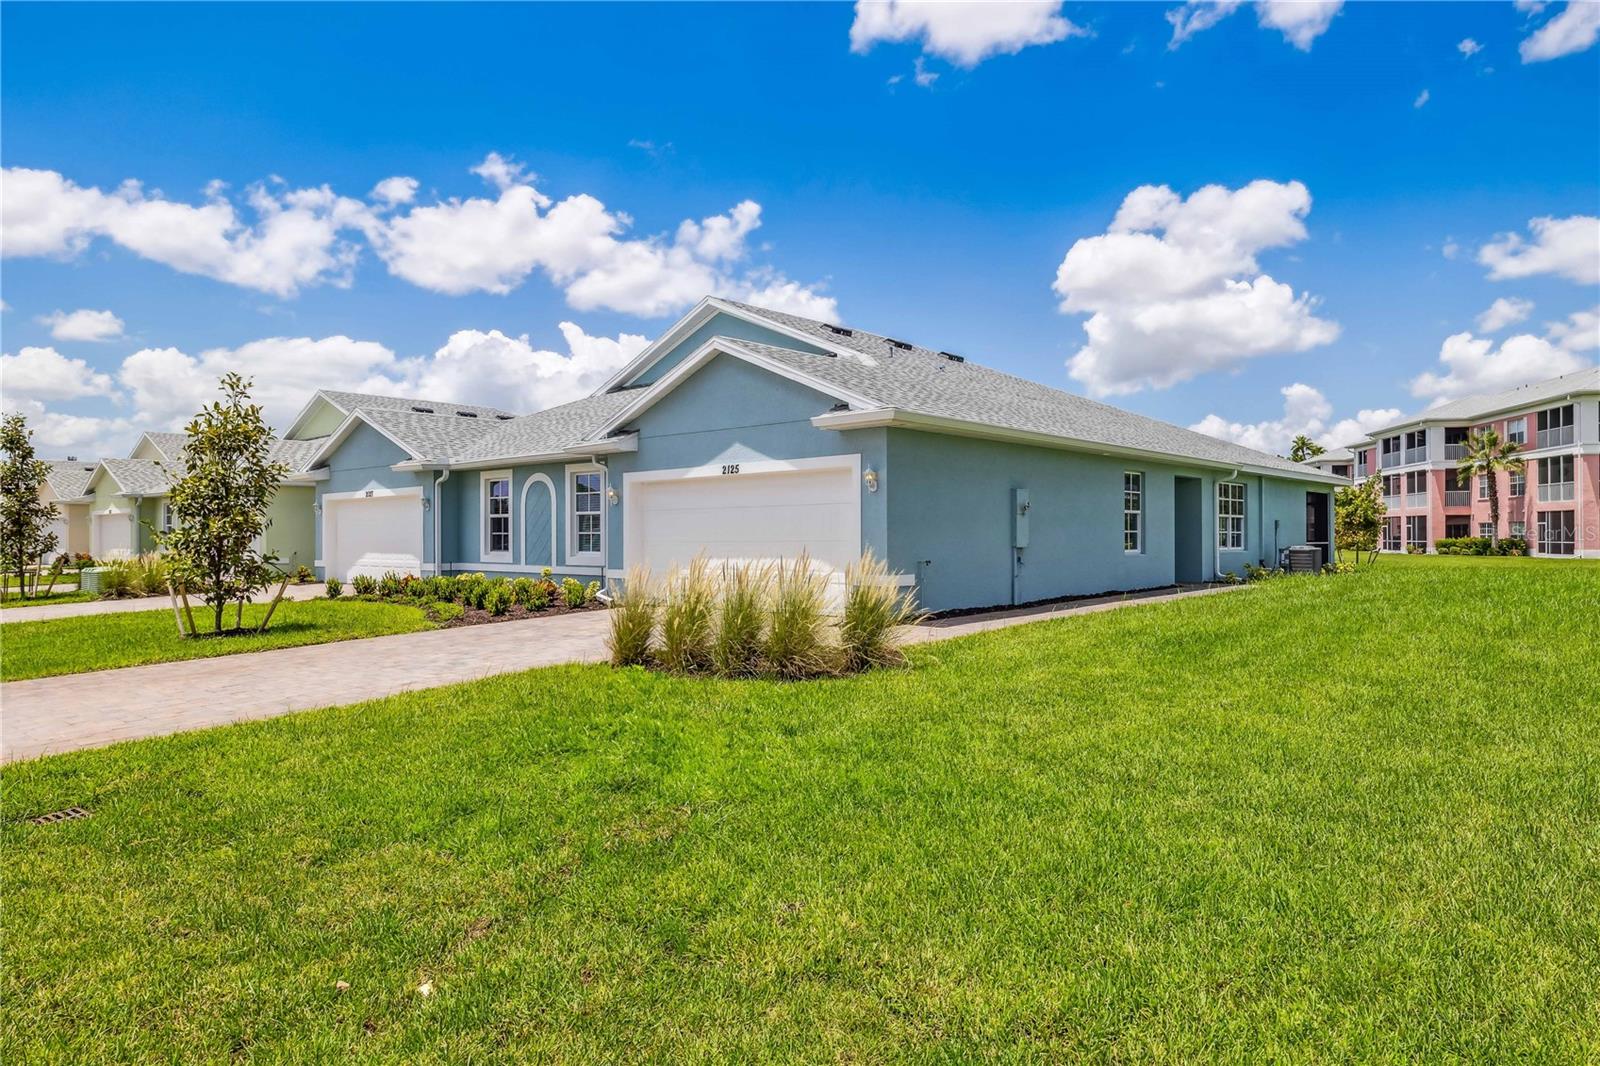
624 456 861 573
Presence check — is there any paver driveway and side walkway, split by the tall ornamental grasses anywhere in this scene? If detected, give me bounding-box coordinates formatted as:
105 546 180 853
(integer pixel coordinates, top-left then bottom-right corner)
0 576 1226 762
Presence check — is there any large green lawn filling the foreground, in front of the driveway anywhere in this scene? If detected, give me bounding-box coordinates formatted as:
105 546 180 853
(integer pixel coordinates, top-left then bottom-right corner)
0 559 1600 1063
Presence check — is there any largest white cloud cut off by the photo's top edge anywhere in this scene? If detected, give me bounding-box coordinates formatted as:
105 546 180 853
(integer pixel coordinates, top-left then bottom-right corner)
850 0 1088 67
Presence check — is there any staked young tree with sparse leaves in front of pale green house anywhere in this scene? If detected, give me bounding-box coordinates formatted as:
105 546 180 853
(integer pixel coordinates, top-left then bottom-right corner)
160 373 288 635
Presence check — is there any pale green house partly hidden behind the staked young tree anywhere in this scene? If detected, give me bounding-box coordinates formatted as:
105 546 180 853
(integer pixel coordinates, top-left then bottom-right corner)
86 432 322 570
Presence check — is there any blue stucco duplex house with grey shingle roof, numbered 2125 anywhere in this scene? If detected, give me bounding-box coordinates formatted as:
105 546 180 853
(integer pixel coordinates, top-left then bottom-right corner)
285 298 1342 610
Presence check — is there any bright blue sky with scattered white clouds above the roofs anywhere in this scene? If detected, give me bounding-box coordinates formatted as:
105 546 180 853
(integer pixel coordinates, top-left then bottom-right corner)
0 2 1600 455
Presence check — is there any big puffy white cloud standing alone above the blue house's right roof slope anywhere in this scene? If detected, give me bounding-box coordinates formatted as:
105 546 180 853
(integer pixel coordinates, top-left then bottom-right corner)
1054 181 1339 395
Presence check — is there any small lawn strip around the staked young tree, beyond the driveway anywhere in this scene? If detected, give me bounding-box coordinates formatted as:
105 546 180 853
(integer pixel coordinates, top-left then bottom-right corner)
0 600 434 681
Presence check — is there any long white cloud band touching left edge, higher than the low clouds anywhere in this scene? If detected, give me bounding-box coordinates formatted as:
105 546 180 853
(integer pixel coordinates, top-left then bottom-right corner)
0 166 368 296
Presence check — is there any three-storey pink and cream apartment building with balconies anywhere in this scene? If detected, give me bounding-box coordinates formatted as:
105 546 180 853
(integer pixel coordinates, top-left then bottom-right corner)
1355 368 1600 559
